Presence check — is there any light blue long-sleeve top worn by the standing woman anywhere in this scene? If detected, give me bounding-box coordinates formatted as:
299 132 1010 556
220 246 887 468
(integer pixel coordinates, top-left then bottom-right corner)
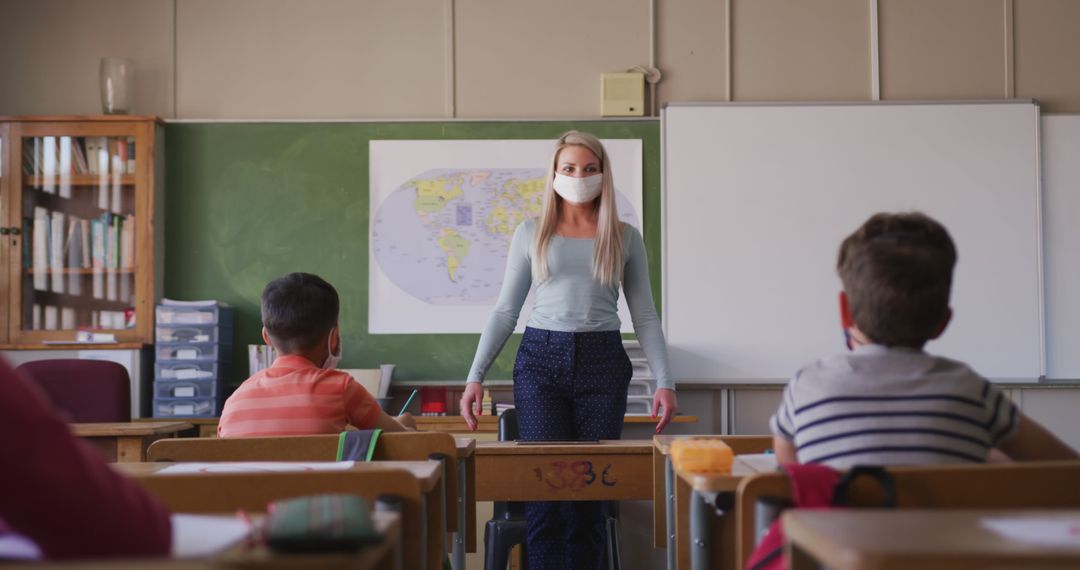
468 220 675 389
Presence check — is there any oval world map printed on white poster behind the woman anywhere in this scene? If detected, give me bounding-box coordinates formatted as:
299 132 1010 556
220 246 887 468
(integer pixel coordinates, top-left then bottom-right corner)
372 168 640 304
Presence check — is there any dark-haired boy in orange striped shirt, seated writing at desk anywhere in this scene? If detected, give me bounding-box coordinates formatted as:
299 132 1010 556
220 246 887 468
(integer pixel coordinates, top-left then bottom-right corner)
217 273 416 437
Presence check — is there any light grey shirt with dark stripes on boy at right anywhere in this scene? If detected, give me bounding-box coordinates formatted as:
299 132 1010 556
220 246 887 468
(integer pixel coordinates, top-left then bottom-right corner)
769 344 1018 469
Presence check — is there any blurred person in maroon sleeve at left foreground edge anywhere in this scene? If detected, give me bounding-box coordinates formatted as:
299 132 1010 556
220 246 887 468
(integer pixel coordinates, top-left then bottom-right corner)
0 358 172 560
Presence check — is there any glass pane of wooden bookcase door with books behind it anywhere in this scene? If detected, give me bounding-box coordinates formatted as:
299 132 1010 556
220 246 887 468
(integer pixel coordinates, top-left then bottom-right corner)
12 125 145 341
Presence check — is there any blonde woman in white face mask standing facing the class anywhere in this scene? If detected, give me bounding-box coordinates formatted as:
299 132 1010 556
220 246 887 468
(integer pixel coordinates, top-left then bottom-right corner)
461 131 676 570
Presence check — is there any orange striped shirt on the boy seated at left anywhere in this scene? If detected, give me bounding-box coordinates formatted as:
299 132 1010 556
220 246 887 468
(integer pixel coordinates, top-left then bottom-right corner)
217 354 382 437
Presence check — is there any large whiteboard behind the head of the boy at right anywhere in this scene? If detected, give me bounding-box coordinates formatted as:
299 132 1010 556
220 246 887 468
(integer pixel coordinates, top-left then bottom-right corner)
661 101 1045 381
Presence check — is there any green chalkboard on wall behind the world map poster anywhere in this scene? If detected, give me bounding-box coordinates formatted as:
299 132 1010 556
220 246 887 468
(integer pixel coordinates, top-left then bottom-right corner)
164 120 660 382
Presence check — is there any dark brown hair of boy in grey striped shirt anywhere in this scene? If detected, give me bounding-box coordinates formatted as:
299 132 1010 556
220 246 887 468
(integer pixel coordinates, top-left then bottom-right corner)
837 212 956 348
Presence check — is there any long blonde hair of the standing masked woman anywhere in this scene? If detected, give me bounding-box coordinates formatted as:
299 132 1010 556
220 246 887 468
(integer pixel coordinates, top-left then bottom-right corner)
532 131 622 286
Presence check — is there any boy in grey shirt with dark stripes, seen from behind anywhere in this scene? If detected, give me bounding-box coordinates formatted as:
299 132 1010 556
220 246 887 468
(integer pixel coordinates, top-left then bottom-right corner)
770 213 1077 469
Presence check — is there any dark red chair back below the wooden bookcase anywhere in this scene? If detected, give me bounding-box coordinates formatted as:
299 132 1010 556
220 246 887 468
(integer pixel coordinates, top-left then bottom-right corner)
15 358 132 423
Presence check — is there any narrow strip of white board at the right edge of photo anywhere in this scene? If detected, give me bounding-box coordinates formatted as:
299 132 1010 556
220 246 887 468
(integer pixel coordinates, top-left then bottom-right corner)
1041 114 1080 380
